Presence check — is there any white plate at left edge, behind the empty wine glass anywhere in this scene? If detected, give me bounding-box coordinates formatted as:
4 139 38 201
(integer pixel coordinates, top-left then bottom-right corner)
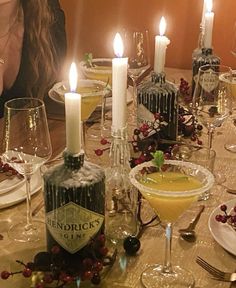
0 169 43 209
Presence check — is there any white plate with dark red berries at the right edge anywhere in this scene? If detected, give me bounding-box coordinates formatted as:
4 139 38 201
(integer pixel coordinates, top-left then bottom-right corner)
208 198 236 256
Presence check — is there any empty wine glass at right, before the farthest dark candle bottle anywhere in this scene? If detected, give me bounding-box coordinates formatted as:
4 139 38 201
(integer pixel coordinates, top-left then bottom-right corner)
193 64 232 148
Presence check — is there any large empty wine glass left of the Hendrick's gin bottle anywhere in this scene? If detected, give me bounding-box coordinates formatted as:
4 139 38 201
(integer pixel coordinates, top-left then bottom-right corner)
2 98 52 242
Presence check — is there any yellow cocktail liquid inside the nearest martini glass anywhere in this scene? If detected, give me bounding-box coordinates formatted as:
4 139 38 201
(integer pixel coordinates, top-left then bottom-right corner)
140 172 202 222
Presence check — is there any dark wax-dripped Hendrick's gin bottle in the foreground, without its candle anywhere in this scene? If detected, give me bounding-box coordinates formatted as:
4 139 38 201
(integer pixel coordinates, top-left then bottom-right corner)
44 153 105 266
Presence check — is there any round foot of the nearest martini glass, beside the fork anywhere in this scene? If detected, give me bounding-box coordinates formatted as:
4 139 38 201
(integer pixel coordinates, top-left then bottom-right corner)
141 265 195 288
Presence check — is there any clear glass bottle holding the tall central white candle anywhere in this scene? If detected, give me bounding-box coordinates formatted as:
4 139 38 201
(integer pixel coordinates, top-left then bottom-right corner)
105 127 138 244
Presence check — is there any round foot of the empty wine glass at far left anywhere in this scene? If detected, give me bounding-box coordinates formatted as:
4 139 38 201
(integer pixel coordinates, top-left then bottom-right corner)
8 220 45 242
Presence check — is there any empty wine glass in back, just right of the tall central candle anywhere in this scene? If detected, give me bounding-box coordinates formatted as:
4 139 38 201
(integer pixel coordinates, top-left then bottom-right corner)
124 30 151 119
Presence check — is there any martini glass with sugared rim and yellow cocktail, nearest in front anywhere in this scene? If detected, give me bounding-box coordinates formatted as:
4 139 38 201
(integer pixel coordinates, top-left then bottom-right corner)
129 160 214 288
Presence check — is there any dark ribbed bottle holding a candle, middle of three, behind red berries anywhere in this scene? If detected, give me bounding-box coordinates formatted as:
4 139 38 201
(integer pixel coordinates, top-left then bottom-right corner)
137 72 179 140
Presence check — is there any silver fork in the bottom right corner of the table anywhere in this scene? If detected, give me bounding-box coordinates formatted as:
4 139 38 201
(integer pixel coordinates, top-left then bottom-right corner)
196 256 236 282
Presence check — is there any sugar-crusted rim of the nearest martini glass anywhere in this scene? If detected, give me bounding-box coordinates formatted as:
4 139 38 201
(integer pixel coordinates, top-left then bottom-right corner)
129 160 215 198
